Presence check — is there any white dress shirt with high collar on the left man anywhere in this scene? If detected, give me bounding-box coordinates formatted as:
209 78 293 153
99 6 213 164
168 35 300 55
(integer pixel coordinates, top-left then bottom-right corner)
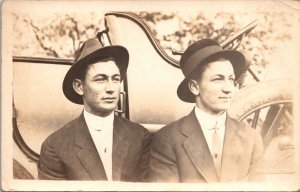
83 110 114 181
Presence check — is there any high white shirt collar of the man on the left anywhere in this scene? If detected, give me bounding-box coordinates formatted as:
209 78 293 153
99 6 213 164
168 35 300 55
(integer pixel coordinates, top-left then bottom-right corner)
83 109 114 130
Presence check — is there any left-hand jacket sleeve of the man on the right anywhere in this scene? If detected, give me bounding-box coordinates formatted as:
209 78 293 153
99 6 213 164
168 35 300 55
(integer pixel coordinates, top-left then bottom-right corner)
149 131 180 182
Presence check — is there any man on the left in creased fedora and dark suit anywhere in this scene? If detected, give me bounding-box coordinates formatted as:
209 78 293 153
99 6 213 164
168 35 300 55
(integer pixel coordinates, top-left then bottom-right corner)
38 36 151 181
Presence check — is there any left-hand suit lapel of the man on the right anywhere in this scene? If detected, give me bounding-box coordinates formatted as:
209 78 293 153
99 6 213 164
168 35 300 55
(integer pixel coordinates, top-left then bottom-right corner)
182 110 219 182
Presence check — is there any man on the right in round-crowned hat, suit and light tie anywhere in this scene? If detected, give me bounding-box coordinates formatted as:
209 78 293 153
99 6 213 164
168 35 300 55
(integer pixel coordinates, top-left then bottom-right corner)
149 39 263 183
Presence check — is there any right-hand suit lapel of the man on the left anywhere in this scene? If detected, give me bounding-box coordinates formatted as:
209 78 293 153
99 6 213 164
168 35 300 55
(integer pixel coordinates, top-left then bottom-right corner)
112 116 129 181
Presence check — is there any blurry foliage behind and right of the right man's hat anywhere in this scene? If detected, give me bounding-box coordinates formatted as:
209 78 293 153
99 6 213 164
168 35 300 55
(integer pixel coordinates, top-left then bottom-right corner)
139 12 292 72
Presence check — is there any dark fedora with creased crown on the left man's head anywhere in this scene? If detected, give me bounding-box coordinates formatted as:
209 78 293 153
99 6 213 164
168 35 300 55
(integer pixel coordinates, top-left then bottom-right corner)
62 38 129 104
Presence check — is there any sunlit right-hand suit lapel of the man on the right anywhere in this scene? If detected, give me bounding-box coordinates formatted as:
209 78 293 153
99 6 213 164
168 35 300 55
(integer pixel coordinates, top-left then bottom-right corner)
221 116 244 181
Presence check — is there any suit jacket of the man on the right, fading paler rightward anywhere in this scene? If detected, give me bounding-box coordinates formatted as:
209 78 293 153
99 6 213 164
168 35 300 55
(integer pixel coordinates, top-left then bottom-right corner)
149 111 263 183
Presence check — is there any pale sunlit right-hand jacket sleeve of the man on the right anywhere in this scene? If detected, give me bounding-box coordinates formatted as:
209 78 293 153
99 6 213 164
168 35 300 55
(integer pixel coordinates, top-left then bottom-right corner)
249 131 265 182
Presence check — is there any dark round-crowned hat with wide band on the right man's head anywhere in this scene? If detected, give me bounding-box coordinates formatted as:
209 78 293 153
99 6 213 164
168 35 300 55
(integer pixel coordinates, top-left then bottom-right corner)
177 39 245 103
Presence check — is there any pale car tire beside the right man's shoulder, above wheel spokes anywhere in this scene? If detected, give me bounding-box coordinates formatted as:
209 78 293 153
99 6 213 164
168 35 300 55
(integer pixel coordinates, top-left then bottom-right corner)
228 79 293 121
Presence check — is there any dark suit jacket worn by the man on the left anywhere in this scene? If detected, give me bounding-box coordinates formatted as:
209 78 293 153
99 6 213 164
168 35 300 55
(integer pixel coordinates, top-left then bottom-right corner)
38 114 151 181
